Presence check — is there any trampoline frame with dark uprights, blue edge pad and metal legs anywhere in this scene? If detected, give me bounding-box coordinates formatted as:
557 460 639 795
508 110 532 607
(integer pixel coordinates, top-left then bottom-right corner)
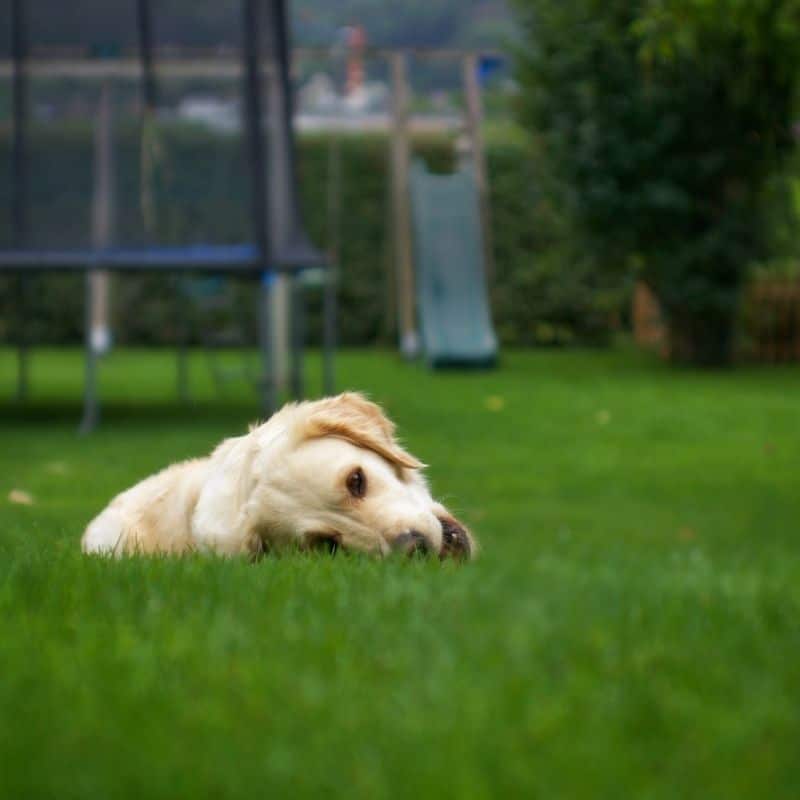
0 0 335 431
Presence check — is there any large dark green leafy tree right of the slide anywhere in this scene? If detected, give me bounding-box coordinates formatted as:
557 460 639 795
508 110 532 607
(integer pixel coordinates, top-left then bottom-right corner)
516 0 800 363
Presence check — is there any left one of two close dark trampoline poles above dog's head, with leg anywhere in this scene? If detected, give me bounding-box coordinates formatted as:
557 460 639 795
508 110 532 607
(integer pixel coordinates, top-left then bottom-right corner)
242 0 275 416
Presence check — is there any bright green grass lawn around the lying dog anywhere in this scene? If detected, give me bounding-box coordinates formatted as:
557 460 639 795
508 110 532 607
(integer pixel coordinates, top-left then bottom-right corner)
0 350 800 800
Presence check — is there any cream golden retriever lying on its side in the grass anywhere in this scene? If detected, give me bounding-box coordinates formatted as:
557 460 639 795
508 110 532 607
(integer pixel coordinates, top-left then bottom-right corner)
81 393 475 559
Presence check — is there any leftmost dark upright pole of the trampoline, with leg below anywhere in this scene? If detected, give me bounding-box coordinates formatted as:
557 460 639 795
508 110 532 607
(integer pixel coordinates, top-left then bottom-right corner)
11 0 29 401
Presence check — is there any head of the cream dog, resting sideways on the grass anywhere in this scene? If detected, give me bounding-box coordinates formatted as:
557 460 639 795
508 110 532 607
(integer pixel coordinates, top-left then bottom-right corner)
245 393 475 559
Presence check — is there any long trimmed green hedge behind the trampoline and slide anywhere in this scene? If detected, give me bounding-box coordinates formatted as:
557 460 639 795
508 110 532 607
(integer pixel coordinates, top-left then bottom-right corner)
0 124 621 345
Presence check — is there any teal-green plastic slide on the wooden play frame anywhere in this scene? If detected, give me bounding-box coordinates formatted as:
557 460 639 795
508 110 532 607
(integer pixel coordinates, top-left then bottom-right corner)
411 161 497 367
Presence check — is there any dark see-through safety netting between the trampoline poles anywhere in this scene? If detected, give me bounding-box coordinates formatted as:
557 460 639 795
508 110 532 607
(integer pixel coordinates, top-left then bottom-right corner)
0 0 292 249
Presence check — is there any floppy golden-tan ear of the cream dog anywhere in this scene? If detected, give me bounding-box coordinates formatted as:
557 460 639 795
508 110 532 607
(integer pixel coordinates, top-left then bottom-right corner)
303 392 425 469
